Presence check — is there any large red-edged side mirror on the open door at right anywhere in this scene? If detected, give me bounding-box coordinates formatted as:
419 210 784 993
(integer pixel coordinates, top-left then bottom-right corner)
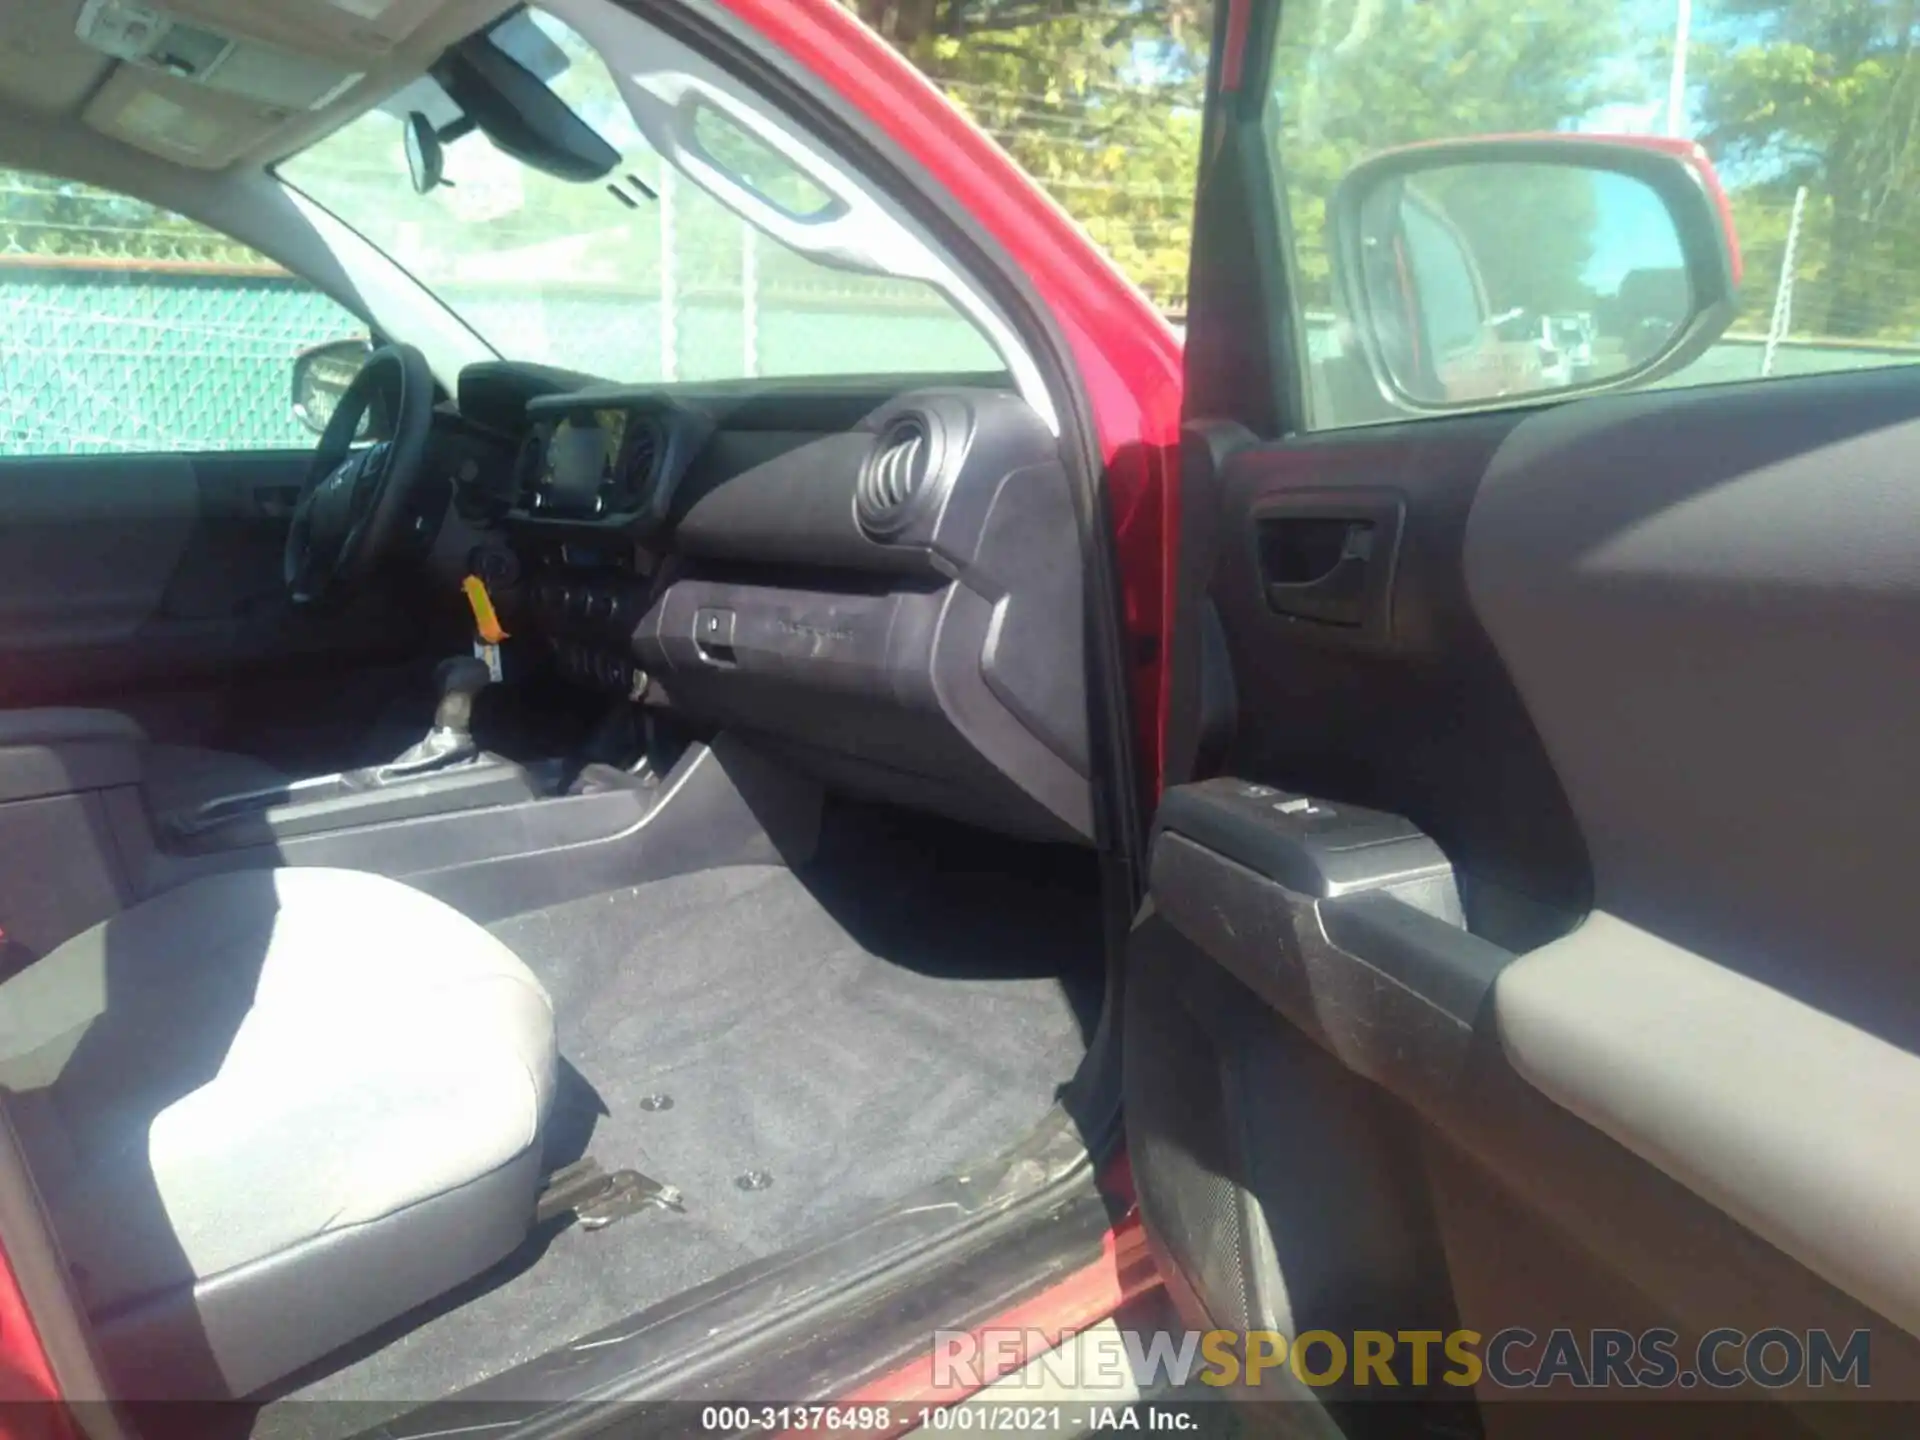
1329 134 1740 411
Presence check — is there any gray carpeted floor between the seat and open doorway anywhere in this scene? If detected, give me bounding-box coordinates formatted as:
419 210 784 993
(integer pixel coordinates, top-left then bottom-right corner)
278 835 1100 1419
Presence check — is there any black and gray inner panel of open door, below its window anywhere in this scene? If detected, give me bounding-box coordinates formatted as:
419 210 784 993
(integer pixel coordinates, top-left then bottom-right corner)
1125 372 1920 1432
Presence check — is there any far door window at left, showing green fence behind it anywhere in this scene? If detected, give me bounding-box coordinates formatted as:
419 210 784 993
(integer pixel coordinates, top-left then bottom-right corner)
0 169 367 455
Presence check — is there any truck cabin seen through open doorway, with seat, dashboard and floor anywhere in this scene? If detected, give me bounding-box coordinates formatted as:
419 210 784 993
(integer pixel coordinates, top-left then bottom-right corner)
0 0 1127 1434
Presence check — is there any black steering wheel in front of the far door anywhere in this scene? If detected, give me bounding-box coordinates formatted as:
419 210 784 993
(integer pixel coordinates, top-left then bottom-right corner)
284 346 434 605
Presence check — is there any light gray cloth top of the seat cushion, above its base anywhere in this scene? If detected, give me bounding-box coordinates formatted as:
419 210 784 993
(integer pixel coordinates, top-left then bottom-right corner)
0 870 555 1319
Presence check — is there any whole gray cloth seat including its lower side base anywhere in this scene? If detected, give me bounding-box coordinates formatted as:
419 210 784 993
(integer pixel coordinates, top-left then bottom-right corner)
0 870 555 1398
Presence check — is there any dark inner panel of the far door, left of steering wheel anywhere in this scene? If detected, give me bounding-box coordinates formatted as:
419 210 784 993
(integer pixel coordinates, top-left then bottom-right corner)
0 451 439 762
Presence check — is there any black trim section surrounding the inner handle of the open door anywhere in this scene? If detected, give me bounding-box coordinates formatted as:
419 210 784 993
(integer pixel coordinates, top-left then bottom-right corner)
1187 415 1590 960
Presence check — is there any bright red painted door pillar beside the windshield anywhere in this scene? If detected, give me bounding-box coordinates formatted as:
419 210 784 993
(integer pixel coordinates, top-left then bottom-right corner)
720 0 1181 797
